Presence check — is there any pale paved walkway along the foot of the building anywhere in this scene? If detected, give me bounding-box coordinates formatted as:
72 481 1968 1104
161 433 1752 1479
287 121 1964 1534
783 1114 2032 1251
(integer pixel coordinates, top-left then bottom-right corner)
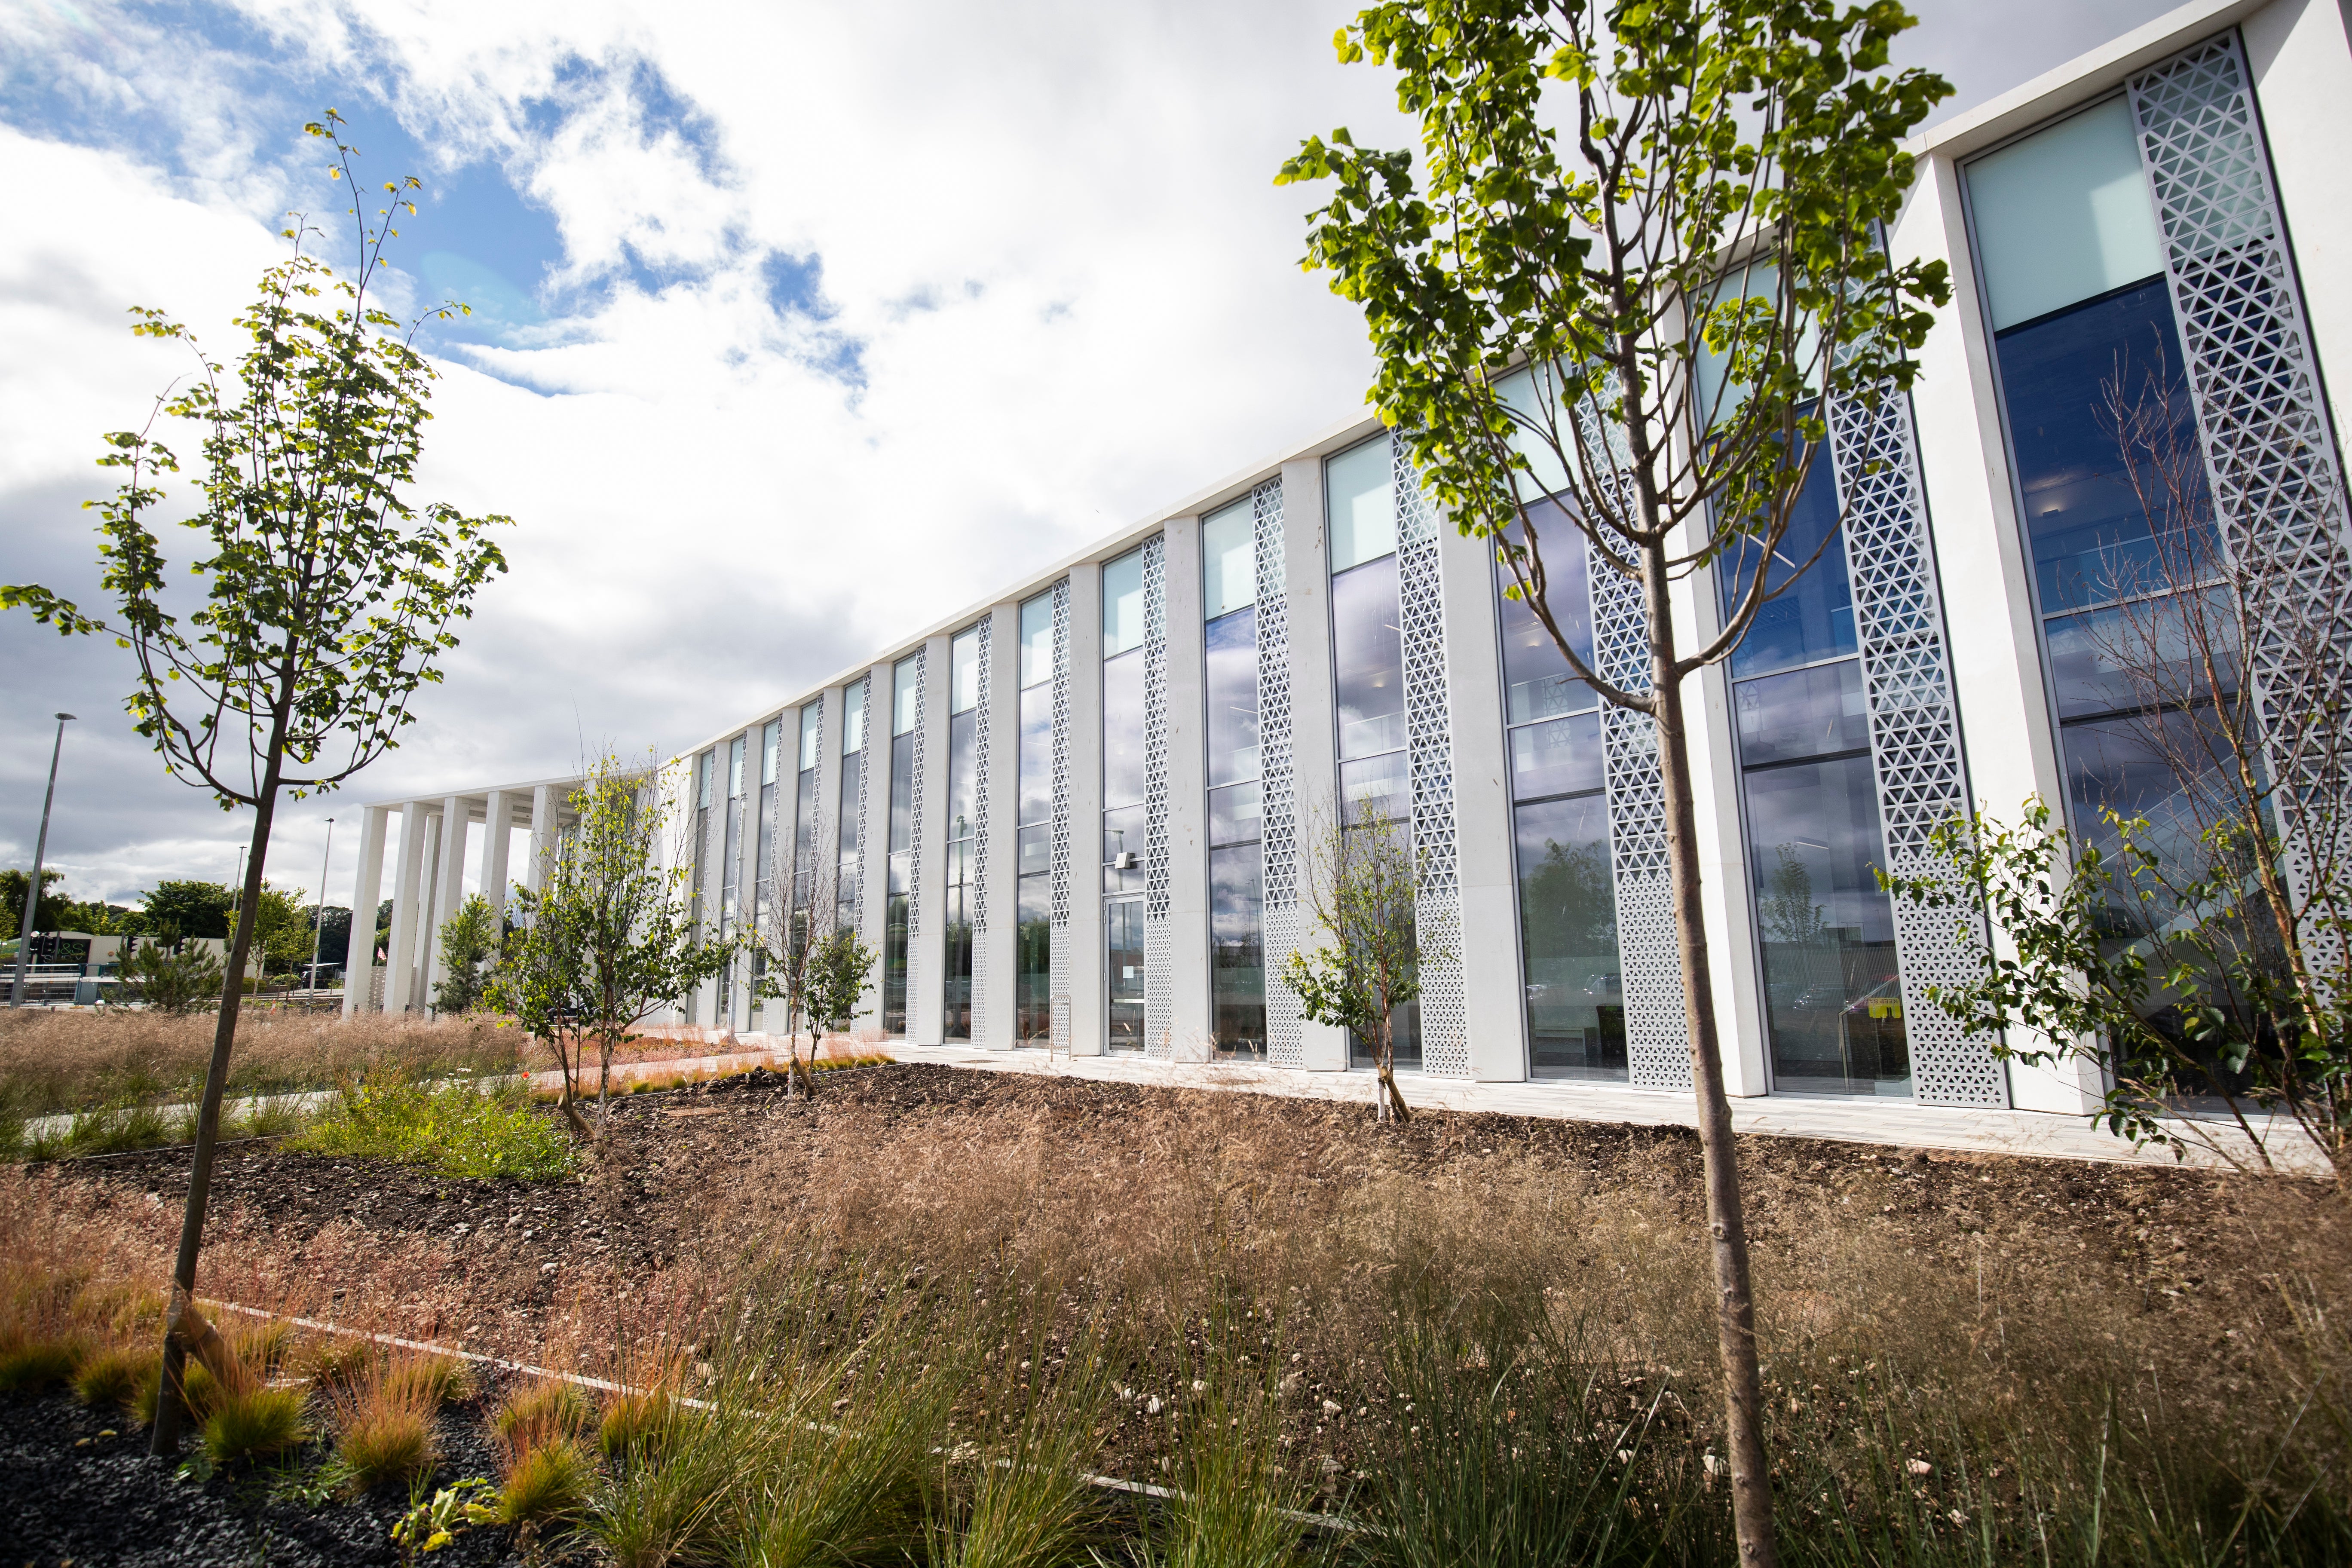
882 1041 2328 1176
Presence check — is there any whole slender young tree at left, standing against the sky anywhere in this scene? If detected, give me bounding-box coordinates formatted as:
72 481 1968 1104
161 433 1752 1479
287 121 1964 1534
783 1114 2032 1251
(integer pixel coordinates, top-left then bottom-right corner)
0 110 505 1453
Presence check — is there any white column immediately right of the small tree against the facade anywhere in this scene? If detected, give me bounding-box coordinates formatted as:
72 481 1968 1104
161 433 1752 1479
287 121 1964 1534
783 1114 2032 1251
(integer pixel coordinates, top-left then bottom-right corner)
1437 520 1526 1084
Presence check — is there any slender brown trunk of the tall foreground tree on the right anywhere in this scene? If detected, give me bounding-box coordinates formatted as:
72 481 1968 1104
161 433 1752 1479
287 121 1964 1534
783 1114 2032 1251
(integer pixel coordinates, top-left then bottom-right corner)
1644 548 1780 1568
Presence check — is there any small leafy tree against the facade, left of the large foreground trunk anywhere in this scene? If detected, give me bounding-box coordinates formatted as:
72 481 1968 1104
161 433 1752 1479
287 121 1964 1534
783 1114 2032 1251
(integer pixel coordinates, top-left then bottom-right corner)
1282 797 1442 1121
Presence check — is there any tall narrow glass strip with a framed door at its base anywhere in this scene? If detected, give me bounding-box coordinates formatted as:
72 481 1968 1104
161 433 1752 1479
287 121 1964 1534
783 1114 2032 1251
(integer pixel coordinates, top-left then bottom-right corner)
1103 550 1145 1051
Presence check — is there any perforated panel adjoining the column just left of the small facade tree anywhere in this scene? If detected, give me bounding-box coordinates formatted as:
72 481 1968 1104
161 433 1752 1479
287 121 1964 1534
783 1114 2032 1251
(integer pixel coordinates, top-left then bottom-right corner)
1249 480 1305 1067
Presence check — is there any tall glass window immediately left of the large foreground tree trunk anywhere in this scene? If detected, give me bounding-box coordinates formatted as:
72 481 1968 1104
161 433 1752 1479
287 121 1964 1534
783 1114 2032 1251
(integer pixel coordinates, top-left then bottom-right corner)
1496 515 1625 1081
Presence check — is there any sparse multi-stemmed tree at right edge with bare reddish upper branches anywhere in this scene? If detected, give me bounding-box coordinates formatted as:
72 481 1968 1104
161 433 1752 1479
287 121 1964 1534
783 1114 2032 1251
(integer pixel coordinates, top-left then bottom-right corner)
1889 364 2352 1182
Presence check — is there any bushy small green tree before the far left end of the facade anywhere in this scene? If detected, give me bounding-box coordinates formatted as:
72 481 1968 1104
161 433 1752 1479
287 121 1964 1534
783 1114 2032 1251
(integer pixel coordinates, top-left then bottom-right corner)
489 752 736 1126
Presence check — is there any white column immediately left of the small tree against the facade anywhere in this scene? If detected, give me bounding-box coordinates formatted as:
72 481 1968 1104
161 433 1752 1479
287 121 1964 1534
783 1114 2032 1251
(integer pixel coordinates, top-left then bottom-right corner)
1265 447 1348 1072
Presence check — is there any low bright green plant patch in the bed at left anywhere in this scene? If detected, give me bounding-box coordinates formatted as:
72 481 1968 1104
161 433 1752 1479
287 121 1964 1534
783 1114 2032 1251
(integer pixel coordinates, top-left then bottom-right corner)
294 1074 576 1180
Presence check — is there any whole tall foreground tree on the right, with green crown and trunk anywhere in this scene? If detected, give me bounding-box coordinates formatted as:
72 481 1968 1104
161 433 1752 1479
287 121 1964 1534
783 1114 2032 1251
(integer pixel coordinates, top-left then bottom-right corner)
1280 0 1950 1568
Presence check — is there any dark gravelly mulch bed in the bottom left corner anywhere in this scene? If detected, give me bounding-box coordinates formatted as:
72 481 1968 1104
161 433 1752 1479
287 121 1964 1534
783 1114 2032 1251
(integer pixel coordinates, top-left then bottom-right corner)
0 1394 541 1568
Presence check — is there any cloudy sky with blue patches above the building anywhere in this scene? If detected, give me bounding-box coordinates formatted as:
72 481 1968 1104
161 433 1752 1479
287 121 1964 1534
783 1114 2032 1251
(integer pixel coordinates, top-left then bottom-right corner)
0 0 2166 912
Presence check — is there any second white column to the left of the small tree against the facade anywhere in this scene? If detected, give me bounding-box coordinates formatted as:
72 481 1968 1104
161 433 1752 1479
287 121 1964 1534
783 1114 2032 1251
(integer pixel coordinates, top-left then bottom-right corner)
1164 517 1216 1063
